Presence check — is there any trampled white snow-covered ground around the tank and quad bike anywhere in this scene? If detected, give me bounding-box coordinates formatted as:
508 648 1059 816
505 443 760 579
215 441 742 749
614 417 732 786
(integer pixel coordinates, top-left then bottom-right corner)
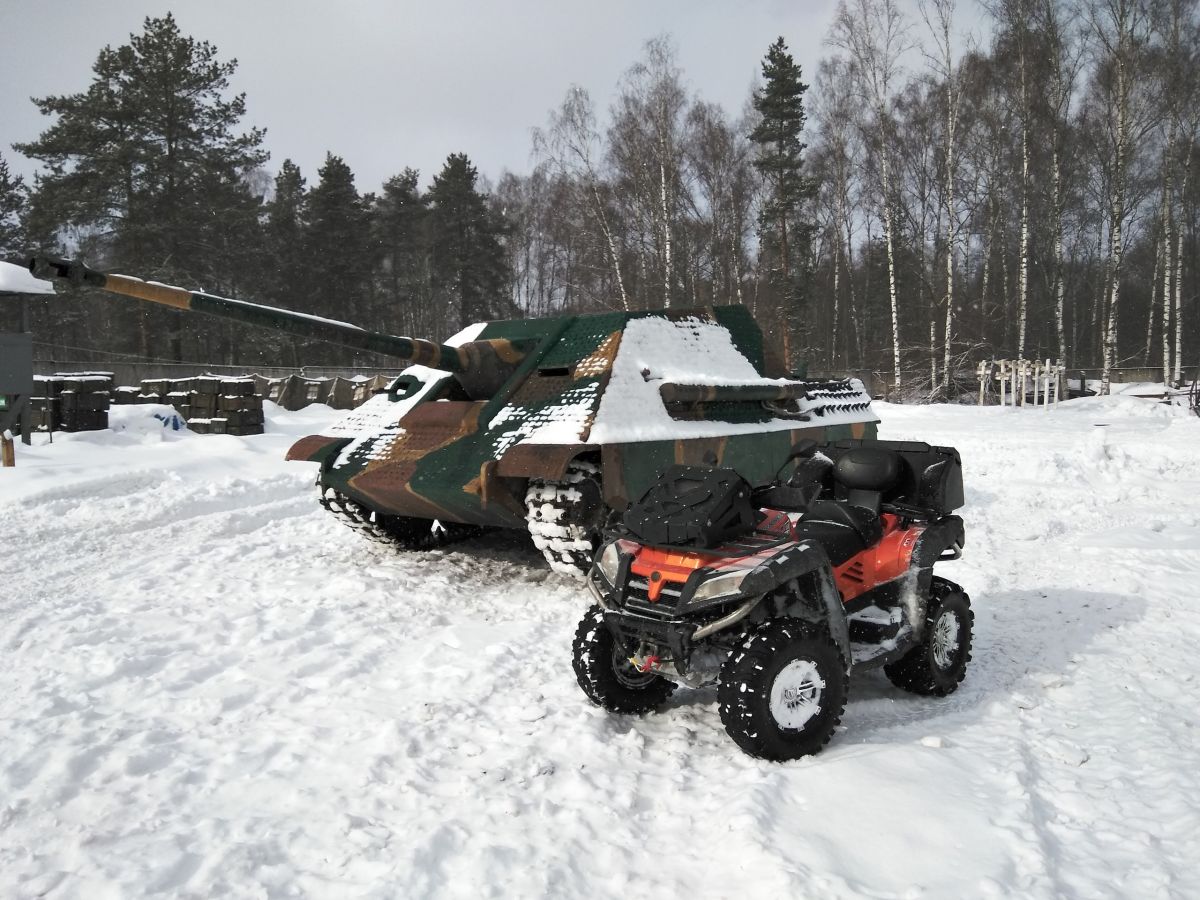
0 397 1200 899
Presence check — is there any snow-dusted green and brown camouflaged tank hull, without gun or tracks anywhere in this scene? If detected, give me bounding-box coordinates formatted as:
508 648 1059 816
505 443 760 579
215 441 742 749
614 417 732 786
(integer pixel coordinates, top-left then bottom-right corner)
289 307 876 528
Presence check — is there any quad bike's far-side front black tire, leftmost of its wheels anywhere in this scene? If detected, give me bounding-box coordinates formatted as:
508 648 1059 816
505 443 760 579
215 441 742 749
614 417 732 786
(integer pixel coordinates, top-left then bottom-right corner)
571 606 676 714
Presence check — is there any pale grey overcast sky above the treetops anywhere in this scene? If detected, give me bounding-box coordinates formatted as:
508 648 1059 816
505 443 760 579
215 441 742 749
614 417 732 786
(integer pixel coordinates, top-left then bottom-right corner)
0 0 979 191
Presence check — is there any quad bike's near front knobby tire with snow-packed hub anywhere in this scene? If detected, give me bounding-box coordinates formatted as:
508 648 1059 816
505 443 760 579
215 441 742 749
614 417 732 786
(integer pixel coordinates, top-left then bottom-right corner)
716 618 848 761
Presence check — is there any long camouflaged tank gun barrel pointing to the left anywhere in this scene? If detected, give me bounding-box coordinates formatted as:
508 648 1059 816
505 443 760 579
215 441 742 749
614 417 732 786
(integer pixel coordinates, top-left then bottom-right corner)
29 256 526 383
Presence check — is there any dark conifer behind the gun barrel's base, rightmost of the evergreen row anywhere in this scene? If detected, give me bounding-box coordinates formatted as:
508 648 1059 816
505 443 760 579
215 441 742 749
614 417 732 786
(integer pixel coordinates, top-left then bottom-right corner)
428 154 512 336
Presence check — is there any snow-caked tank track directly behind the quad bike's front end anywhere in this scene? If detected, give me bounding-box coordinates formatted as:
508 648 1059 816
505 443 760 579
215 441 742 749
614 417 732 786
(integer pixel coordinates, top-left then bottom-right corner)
526 460 608 577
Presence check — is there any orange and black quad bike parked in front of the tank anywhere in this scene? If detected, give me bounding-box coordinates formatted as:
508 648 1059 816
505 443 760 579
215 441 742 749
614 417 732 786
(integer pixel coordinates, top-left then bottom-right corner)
574 440 973 760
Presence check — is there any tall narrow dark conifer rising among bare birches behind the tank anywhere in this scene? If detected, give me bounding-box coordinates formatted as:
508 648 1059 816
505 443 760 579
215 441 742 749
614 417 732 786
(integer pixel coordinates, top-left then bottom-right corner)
750 37 815 366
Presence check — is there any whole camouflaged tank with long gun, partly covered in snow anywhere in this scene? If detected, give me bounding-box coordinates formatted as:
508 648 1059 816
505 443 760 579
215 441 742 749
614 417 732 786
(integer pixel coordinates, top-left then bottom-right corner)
30 257 877 571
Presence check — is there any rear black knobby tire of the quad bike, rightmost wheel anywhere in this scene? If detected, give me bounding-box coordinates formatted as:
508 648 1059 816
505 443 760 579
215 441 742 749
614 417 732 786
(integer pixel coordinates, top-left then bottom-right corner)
883 576 974 697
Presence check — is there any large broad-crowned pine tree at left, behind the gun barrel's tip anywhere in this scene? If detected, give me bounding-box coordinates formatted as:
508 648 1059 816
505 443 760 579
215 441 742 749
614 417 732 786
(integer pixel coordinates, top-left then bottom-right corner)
16 13 268 359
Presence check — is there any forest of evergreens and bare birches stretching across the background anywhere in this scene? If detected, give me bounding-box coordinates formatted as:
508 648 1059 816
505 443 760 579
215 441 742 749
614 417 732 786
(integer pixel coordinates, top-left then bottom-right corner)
0 0 1200 397
